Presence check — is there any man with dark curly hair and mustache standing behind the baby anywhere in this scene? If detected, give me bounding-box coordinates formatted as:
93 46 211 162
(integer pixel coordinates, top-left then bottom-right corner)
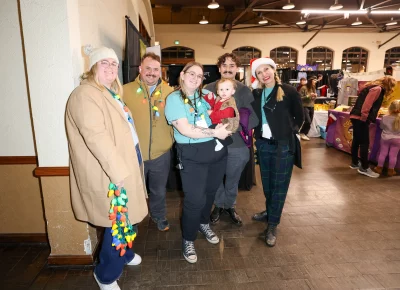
205 53 258 226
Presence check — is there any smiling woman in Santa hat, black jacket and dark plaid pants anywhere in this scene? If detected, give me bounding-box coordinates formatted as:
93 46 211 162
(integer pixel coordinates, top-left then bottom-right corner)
251 58 304 247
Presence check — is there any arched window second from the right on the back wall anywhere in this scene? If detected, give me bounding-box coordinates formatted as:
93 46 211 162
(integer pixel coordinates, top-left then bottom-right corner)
342 47 368 73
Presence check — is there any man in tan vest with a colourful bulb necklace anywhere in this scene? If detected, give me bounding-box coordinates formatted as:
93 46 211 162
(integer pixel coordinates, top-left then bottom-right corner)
123 53 173 231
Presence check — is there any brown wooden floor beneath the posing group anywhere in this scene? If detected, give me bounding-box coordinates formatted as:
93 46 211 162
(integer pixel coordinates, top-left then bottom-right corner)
0 139 400 290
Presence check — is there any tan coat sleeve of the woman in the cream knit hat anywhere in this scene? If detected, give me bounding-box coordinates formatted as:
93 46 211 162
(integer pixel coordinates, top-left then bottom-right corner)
67 92 129 183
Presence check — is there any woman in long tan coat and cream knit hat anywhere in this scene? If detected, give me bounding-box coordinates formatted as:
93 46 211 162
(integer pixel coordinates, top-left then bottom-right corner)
66 47 147 289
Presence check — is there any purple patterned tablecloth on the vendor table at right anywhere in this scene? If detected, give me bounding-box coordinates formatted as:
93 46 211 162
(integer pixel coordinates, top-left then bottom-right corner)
326 110 400 169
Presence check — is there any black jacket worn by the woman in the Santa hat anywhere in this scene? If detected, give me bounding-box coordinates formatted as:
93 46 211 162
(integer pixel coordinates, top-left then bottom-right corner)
252 84 304 141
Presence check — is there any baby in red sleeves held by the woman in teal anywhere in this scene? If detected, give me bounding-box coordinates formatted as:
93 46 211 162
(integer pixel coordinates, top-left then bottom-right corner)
205 79 239 151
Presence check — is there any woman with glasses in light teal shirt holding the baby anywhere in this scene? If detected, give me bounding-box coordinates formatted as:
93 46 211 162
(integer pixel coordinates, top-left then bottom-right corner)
165 62 231 263
